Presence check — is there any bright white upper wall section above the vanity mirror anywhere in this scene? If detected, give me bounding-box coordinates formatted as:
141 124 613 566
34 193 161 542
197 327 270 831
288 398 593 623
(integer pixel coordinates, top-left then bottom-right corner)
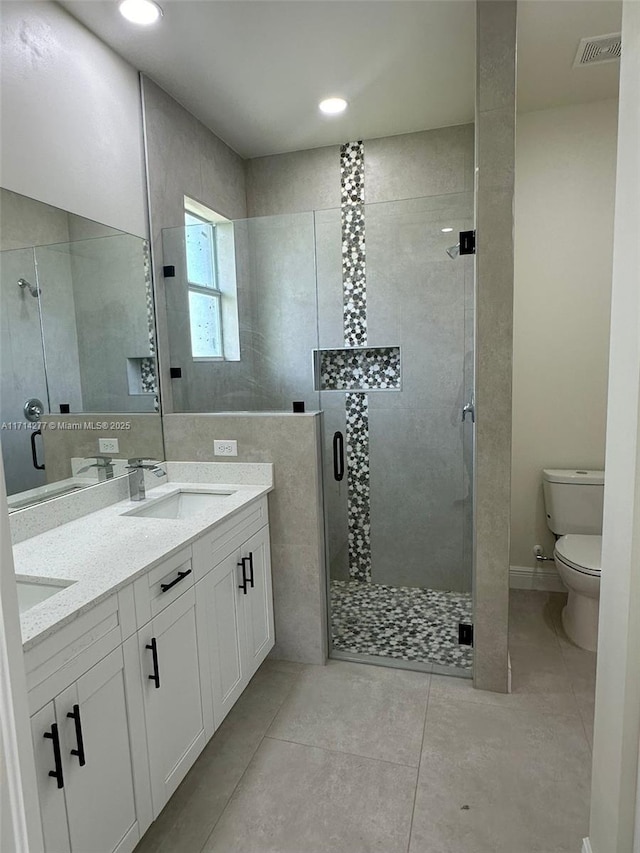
0 2 147 236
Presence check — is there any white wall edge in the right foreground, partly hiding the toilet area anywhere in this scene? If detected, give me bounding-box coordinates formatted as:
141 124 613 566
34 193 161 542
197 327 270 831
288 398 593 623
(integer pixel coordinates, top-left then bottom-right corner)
590 0 640 853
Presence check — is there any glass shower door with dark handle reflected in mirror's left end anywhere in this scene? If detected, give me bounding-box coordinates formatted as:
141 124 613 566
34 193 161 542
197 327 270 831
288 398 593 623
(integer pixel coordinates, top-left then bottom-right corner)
0 249 49 495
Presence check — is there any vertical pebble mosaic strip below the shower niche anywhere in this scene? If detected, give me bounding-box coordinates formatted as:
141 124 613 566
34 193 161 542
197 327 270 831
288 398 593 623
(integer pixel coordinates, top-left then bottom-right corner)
345 393 371 581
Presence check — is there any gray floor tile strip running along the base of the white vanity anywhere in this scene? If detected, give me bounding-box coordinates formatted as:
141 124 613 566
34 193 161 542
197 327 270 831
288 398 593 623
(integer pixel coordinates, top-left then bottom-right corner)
136 664 297 853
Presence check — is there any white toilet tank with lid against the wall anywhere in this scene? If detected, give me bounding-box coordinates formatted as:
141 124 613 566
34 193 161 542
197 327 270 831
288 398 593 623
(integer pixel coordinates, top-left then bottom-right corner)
542 468 604 536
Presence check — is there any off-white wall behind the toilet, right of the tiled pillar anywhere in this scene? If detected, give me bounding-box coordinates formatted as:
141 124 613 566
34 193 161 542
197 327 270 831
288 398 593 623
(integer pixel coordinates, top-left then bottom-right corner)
511 101 617 567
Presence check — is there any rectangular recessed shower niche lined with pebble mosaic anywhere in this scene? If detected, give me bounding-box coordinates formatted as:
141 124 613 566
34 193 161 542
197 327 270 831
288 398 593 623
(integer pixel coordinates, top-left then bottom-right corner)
314 347 401 391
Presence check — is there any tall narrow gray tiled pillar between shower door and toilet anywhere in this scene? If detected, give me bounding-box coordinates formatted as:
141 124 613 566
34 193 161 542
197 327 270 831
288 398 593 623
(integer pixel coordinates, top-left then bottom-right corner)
474 0 516 692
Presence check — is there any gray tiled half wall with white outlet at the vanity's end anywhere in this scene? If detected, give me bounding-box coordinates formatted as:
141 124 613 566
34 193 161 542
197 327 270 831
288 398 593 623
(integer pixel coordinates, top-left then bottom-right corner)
163 414 327 664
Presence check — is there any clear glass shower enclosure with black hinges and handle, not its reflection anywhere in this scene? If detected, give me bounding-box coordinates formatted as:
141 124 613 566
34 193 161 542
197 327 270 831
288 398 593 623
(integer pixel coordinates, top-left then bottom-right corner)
162 193 474 675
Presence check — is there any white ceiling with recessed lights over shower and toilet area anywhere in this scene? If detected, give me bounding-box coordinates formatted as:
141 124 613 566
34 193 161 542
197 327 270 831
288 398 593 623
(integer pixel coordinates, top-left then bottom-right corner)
62 0 621 157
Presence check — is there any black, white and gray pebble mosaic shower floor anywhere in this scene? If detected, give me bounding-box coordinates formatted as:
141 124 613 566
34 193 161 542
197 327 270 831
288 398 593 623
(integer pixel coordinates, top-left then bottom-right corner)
331 580 473 669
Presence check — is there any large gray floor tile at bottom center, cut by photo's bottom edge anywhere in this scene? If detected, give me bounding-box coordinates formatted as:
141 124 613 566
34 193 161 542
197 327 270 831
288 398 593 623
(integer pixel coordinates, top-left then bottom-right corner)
204 738 416 853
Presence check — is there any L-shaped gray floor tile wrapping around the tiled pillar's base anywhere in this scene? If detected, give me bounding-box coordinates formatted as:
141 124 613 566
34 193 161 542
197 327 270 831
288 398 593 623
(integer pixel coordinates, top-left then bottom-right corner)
430 642 579 716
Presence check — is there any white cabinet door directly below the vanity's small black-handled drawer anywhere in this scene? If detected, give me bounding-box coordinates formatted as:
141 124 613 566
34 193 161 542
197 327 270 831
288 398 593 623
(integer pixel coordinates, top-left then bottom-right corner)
138 588 206 817
